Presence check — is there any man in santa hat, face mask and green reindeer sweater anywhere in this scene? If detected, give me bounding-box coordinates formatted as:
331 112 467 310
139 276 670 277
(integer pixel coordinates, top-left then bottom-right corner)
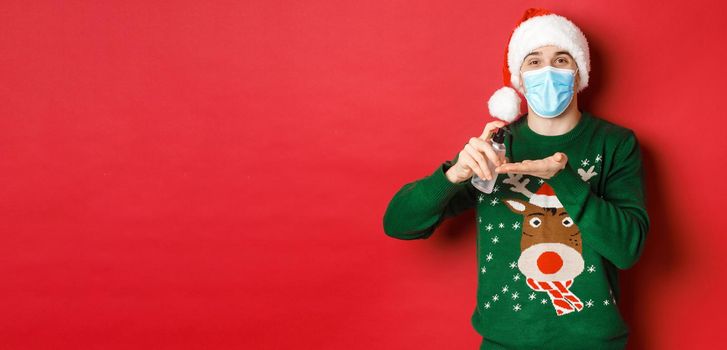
384 9 650 349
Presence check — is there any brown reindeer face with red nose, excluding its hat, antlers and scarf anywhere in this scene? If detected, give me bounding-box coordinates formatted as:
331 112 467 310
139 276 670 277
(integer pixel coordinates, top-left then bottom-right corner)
503 199 584 281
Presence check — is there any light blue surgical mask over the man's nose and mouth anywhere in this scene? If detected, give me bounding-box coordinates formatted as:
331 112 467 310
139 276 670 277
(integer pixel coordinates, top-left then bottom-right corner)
522 66 578 118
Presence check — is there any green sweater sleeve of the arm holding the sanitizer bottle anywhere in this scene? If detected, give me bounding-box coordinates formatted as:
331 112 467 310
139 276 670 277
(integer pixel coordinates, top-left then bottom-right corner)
384 155 477 240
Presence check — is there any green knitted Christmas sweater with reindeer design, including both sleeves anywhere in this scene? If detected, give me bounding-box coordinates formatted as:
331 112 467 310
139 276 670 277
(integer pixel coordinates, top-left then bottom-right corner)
383 112 650 349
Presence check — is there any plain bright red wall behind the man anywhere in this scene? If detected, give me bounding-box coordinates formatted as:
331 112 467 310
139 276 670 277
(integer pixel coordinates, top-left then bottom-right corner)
0 0 727 349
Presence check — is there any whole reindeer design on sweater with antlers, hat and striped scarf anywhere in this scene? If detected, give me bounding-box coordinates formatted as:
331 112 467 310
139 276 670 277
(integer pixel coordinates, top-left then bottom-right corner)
503 174 584 316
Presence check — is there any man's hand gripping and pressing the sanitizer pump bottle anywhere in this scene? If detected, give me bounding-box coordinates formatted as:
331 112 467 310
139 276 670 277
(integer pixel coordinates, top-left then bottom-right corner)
446 120 508 183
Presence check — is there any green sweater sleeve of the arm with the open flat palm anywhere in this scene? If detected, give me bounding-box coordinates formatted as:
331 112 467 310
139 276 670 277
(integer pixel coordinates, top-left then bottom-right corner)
546 130 650 270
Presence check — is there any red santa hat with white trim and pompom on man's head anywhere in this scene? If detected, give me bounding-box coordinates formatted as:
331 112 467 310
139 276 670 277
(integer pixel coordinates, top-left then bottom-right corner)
487 8 591 122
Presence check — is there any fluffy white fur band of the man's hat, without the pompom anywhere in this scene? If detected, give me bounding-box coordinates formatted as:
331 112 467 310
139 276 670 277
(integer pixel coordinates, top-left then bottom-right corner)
507 14 591 93
